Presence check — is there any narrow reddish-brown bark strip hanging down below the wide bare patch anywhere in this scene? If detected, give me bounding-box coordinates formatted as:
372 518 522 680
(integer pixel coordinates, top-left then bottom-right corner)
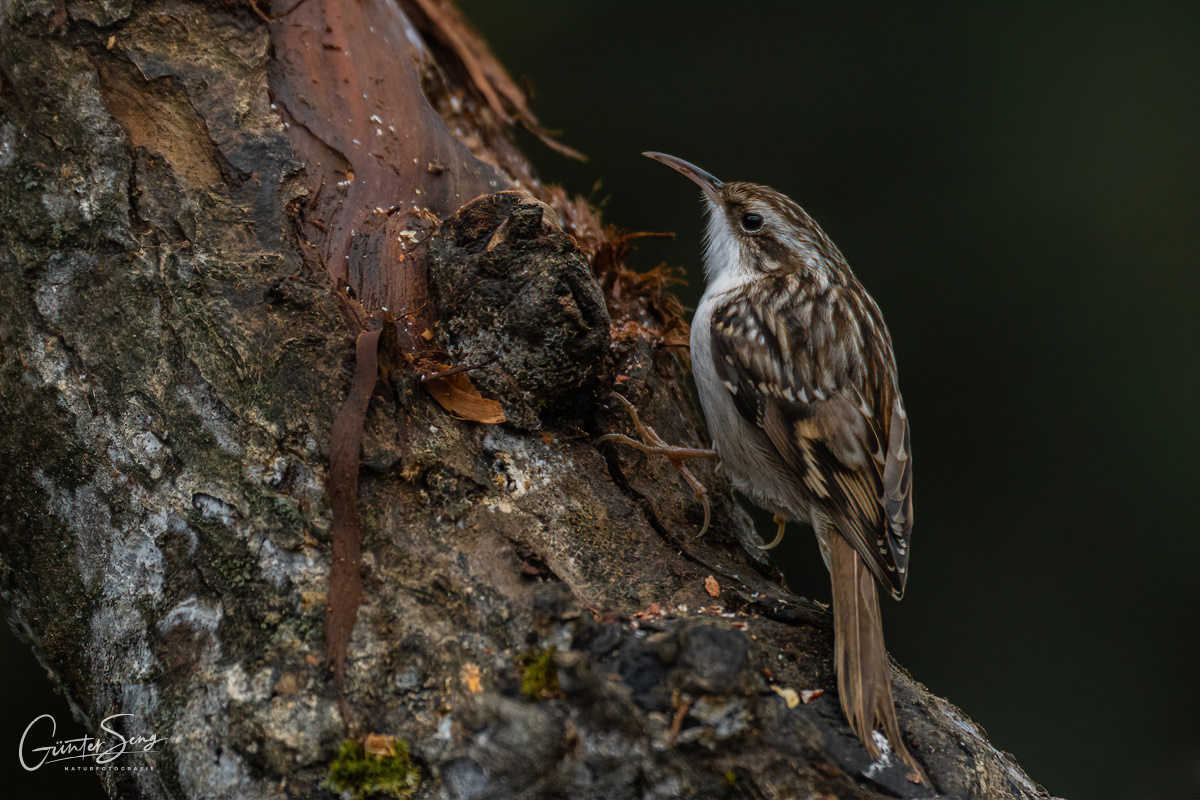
325 329 383 724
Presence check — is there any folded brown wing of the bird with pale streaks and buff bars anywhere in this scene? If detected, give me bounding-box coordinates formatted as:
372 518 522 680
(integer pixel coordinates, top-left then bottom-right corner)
710 284 912 597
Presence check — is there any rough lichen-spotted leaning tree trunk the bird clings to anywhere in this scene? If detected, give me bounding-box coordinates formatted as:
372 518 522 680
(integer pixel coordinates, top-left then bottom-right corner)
0 0 1043 798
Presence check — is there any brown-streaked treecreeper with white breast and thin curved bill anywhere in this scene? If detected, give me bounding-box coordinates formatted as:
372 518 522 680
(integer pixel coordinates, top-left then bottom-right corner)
643 152 924 782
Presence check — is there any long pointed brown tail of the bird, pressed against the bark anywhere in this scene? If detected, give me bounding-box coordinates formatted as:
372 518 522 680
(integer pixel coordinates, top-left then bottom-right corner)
827 531 929 784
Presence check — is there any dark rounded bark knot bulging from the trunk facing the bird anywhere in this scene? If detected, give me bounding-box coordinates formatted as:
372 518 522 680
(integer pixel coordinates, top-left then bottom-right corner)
428 192 610 428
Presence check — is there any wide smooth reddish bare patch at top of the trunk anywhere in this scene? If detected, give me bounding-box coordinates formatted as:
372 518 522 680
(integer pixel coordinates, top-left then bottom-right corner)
270 0 510 296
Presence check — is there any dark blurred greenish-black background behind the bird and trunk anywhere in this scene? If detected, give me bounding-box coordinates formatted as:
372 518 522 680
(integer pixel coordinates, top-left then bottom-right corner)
0 0 1200 798
